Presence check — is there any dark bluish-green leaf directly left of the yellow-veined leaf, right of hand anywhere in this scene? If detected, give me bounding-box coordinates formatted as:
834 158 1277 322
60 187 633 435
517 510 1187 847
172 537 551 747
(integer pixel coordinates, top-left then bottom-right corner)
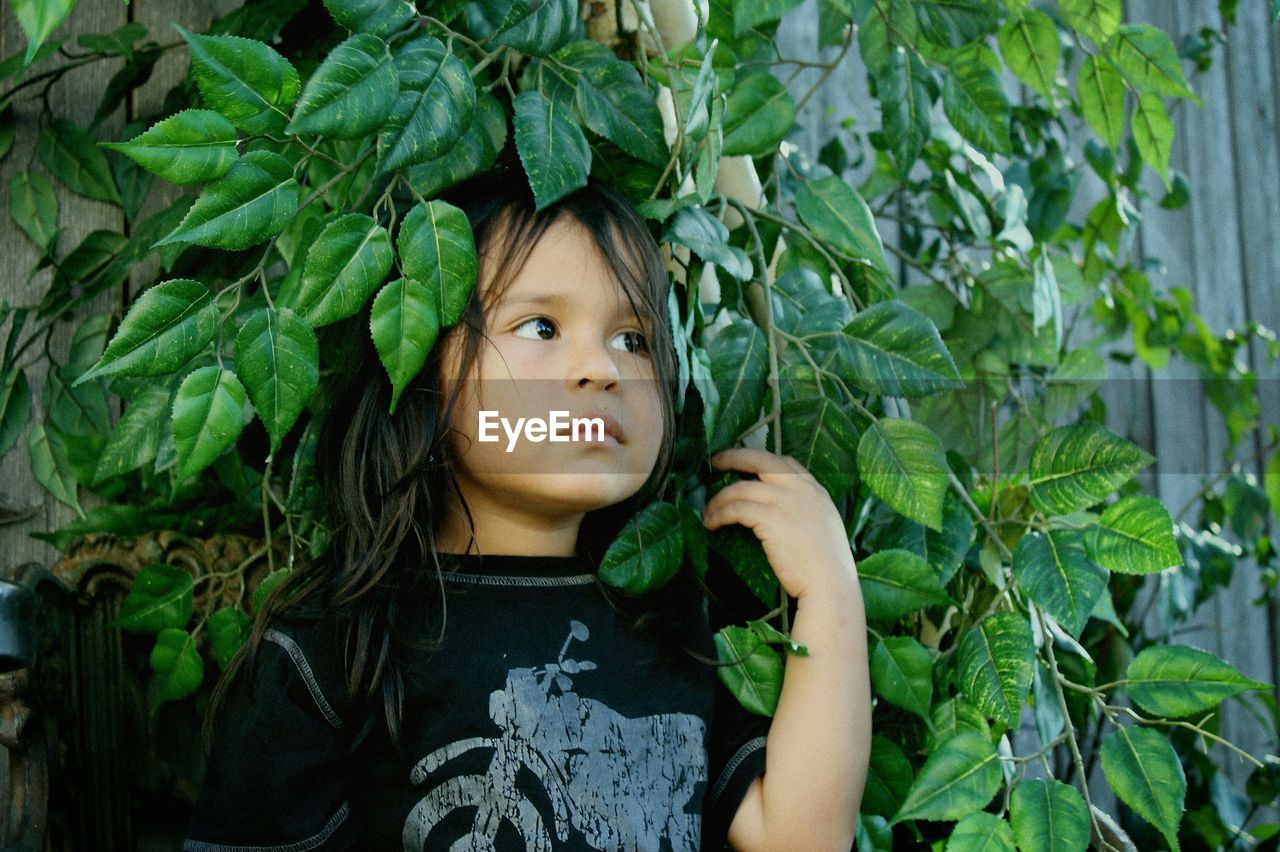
1014 528 1107 637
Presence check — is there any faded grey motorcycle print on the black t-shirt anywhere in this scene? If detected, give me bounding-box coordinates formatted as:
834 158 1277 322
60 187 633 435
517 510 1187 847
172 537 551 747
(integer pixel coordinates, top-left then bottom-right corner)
403 620 707 852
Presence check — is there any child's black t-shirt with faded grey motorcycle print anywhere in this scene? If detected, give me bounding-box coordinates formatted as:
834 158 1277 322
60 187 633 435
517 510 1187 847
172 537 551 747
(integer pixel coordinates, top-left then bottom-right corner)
183 547 772 852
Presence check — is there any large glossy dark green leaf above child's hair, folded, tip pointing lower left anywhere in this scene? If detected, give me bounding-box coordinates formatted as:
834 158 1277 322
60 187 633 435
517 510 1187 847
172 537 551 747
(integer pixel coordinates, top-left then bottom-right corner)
378 36 476 174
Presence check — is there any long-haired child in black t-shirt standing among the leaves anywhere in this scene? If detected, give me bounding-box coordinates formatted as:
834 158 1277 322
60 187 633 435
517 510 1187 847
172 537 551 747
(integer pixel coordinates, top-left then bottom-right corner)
183 164 870 852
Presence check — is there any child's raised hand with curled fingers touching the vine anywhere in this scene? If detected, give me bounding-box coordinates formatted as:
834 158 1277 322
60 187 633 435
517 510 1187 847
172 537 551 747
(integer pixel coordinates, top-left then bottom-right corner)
703 448 856 597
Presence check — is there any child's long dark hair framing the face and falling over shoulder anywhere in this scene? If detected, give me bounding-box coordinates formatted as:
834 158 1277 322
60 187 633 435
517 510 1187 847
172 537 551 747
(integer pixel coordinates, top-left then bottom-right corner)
205 159 704 747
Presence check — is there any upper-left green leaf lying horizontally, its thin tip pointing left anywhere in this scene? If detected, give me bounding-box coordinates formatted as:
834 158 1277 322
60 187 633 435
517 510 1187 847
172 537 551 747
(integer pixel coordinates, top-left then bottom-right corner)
100 110 239 184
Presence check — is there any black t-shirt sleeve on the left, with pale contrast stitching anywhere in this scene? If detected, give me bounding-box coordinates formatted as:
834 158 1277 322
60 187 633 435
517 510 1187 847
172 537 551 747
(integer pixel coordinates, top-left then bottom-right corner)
182 614 358 852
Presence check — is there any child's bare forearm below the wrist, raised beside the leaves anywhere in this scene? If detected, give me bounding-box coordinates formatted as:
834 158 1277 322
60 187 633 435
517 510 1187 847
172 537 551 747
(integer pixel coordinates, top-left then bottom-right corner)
760 559 872 849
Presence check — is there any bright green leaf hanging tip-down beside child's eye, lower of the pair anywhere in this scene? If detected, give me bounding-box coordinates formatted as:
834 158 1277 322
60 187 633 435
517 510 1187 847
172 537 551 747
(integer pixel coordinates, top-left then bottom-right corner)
370 278 440 414
